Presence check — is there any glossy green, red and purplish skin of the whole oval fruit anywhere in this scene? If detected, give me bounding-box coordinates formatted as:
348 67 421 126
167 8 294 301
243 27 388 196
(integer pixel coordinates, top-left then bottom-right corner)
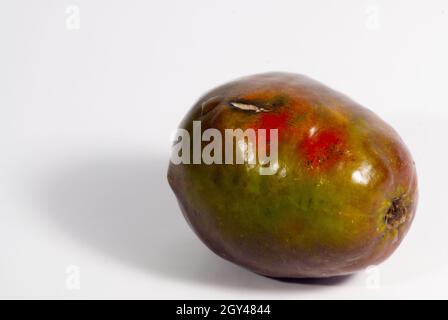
168 72 417 278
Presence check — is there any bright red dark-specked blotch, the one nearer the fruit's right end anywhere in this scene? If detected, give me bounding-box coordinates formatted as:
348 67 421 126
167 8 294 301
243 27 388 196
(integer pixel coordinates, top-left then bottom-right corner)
299 129 346 169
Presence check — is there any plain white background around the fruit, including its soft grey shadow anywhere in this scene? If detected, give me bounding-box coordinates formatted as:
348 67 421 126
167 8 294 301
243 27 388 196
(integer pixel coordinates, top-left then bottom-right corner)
0 0 448 299
